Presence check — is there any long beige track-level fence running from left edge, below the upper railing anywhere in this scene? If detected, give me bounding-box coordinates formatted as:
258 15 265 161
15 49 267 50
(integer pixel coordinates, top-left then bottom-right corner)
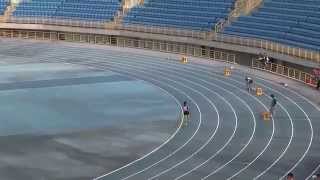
0 29 236 64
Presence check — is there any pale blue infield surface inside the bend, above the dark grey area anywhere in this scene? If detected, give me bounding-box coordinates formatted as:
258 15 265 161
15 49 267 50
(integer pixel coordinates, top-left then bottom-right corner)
0 64 178 136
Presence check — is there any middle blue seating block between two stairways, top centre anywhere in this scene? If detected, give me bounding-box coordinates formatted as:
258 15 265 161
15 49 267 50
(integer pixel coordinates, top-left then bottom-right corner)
124 0 235 31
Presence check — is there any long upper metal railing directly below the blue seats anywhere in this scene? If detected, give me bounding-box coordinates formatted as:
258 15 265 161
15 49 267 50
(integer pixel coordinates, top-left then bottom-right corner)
4 17 320 64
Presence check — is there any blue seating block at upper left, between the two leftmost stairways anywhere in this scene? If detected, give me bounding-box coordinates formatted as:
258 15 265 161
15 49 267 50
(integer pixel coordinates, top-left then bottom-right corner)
13 0 120 21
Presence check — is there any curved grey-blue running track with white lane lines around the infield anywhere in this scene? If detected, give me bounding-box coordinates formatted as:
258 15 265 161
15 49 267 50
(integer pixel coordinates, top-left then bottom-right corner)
29 47 320 180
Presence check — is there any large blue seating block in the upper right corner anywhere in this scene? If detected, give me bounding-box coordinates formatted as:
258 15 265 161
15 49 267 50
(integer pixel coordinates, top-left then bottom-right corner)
224 0 320 51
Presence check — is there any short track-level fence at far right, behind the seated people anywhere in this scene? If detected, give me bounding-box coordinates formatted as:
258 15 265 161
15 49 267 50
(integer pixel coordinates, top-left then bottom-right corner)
251 59 317 86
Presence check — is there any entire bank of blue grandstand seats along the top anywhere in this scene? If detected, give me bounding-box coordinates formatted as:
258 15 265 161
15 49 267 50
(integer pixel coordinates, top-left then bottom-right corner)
0 0 320 51
